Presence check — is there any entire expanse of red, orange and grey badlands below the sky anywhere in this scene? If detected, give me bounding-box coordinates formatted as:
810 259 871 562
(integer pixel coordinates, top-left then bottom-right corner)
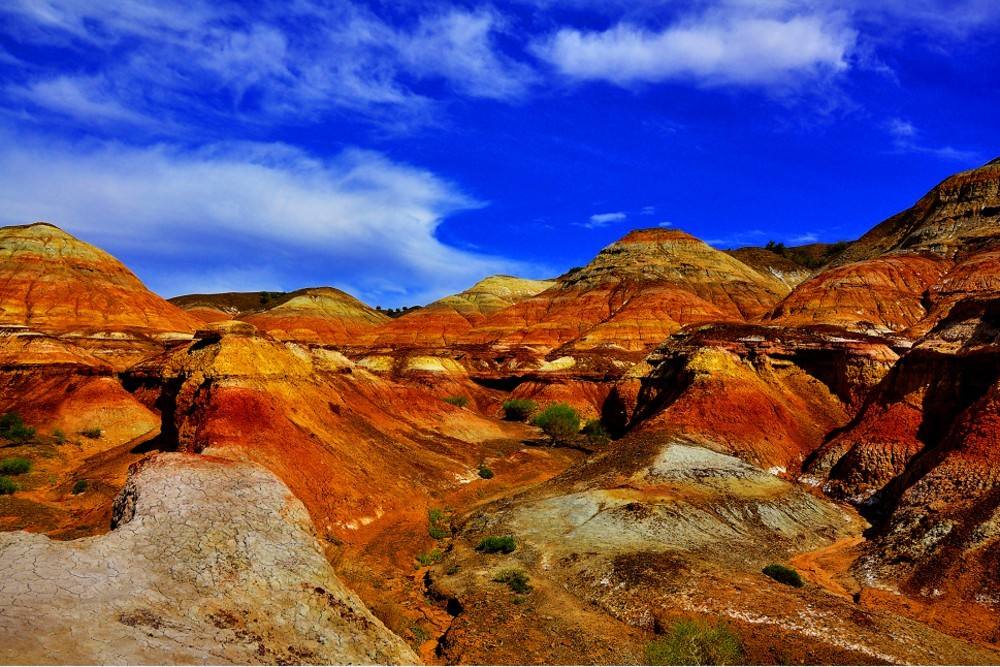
0 161 1000 664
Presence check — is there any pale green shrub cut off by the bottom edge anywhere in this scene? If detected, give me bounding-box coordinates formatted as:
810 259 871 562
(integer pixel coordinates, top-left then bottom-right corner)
646 619 743 665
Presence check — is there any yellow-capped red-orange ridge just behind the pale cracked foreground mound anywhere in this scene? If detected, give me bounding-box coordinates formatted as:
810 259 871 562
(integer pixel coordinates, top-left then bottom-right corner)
123 322 506 541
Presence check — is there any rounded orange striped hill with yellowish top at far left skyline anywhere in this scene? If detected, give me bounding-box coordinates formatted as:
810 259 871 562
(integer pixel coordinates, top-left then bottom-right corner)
0 222 199 367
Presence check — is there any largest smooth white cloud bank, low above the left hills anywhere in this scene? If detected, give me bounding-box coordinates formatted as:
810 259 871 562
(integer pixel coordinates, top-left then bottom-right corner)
0 135 544 305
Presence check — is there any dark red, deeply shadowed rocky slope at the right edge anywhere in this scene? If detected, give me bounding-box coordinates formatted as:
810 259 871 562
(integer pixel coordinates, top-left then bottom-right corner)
811 299 1000 605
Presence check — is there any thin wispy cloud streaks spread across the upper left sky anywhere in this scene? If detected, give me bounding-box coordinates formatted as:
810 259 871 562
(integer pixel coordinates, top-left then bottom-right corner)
0 0 535 129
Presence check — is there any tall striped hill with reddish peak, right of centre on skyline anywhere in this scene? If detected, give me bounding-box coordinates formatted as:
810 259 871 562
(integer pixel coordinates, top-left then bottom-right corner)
467 228 787 358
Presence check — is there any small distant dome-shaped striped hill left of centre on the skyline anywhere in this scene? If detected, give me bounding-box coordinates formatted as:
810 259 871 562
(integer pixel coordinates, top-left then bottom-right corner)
242 287 390 345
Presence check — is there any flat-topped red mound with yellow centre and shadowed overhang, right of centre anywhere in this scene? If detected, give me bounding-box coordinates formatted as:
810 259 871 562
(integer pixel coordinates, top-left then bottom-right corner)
620 324 897 470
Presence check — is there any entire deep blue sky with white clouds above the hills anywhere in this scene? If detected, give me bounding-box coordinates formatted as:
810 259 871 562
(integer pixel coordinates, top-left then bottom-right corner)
0 0 1000 306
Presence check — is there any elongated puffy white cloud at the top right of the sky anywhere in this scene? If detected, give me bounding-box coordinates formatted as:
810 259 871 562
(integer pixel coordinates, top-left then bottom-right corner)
535 12 857 86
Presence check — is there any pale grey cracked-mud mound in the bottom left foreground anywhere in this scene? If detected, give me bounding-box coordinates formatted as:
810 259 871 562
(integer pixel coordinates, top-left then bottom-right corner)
0 454 417 665
